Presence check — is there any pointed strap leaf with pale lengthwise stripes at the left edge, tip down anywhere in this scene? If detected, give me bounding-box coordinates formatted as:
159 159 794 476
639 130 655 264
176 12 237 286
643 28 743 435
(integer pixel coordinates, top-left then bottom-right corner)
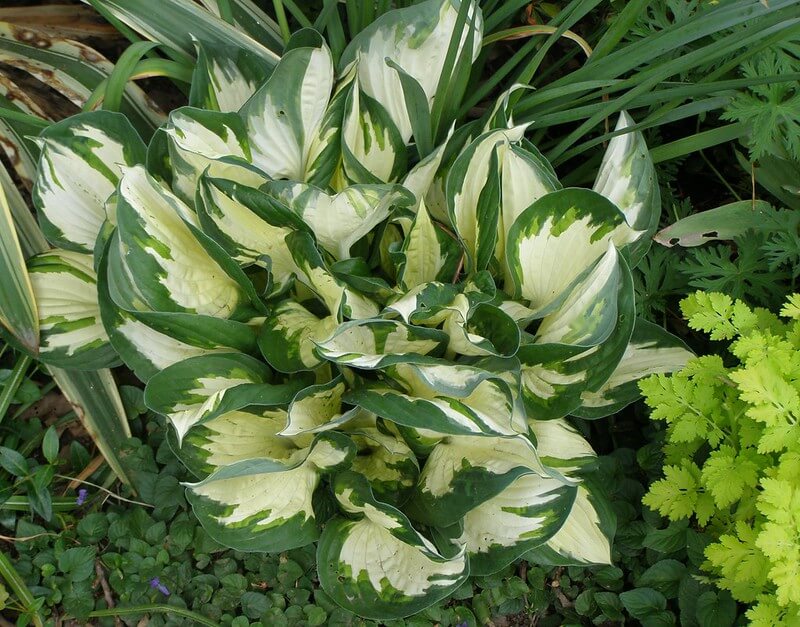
0 178 41 354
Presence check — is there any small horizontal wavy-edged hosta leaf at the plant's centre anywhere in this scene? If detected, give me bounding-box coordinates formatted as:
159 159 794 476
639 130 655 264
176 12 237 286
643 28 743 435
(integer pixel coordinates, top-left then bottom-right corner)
317 319 447 370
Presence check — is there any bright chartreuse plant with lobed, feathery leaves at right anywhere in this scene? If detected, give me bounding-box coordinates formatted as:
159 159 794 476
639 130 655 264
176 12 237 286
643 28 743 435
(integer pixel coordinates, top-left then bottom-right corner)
640 292 800 627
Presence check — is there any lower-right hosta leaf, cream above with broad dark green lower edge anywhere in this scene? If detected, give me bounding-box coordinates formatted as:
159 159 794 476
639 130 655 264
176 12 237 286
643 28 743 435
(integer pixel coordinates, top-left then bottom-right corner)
412 435 548 527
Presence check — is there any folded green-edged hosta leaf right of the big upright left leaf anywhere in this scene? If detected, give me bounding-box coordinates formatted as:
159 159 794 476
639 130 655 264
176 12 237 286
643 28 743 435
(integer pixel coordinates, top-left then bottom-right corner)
197 177 307 293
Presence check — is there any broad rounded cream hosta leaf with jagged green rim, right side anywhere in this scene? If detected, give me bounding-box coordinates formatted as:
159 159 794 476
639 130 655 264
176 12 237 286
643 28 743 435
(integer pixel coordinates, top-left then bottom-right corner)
505 188 625 313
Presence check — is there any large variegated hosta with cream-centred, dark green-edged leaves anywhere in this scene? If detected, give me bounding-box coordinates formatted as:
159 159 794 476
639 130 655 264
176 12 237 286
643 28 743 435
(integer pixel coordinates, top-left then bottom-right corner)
23 0 688 618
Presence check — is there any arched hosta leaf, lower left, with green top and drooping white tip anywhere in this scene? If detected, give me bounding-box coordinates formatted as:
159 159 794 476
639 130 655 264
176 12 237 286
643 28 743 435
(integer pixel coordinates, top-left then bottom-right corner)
145 353 276 444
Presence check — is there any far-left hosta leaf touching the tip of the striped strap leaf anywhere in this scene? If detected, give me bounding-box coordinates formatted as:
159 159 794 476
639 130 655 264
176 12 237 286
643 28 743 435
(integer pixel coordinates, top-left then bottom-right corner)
28 250 119 370
